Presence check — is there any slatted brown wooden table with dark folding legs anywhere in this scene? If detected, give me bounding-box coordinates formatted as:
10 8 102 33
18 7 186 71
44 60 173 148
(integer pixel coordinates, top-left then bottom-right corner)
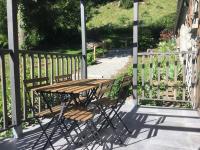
33 79 113 111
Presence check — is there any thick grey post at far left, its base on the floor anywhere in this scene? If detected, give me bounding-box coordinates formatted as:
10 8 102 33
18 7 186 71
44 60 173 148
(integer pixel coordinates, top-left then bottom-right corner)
7 0 22 138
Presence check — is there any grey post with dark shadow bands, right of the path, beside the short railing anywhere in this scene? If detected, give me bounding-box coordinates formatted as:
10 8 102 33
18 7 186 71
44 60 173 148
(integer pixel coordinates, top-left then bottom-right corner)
133 0 139 104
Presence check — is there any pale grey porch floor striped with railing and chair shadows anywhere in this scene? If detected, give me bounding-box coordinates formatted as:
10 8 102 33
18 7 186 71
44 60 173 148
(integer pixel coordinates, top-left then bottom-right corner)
0 100 200 150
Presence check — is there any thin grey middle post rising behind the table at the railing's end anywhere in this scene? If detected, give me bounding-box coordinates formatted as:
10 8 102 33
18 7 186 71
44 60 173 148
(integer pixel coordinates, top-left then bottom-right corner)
80 0 87 79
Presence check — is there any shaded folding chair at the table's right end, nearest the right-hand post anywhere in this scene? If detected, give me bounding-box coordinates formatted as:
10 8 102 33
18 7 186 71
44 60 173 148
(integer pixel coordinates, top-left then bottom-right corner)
96 75 132 141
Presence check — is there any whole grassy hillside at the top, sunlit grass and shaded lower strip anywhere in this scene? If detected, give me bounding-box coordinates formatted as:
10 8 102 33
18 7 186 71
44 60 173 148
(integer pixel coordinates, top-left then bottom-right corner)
87 0 177 49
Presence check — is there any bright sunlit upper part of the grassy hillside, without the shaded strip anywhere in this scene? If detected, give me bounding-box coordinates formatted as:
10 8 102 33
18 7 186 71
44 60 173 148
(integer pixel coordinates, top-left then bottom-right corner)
87 0 177 29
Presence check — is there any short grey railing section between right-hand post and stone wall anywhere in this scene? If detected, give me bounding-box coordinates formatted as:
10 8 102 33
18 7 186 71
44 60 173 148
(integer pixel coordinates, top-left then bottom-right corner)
138 51 197 104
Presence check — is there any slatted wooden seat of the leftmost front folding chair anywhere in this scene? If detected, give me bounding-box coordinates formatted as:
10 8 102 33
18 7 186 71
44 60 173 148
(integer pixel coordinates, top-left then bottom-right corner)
36 105 61 117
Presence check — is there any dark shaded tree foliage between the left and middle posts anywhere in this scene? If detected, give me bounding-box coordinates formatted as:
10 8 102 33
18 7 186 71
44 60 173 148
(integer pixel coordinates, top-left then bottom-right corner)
20 0 80 46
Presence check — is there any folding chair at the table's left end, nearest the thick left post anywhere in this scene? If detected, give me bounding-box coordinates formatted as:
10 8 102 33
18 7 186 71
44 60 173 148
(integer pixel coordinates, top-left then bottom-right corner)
24 77 73 149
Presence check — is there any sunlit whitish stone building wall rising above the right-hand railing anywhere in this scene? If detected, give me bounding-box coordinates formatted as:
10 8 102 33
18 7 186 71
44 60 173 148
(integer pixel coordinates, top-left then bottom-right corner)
177 0 199 51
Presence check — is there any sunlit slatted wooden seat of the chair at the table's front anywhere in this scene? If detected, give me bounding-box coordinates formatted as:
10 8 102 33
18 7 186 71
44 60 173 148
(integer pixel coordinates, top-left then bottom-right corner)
63 108 94 122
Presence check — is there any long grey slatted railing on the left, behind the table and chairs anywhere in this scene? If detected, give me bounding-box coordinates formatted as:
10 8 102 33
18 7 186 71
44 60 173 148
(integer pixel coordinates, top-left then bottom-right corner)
0 49 81 131
